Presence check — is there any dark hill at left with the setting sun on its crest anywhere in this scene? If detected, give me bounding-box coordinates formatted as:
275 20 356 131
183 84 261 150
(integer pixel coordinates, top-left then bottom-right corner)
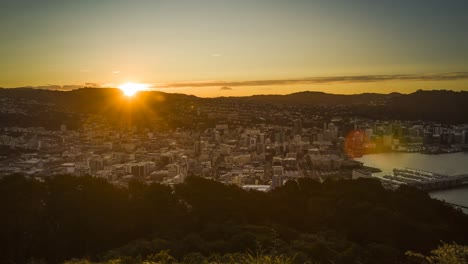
0 88 200 129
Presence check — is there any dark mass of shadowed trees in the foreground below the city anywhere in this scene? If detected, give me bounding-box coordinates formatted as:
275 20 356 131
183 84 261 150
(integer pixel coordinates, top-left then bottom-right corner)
0 176 468 263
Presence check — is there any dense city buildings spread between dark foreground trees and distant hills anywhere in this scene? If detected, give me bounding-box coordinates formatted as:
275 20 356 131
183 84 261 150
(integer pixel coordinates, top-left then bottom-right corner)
0 103 468 191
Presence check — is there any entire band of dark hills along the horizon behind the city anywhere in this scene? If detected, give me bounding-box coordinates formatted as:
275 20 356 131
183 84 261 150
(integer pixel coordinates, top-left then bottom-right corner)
0 88 468 129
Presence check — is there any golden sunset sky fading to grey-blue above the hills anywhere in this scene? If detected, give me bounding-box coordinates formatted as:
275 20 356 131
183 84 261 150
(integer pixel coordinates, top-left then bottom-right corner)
0 0 468 96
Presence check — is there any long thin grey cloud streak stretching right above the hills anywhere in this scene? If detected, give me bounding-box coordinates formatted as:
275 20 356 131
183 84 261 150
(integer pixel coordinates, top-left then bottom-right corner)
159 72 468 87
